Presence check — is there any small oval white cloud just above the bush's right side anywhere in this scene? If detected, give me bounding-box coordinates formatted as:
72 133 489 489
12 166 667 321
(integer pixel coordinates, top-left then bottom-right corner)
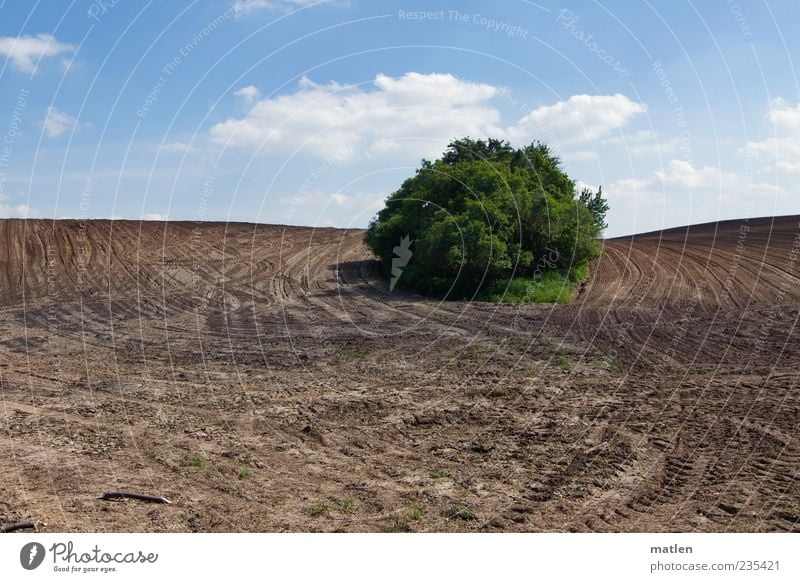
508 93 646 149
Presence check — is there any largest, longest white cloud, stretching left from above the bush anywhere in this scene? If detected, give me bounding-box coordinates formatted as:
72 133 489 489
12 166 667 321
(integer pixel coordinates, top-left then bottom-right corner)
211 73 501 158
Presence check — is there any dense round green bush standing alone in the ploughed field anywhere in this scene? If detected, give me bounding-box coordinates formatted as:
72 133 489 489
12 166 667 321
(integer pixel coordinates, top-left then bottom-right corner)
366 138 608 301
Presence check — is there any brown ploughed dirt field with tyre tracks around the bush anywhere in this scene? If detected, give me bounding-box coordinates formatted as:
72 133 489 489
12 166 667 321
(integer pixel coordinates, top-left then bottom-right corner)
0 217 800 531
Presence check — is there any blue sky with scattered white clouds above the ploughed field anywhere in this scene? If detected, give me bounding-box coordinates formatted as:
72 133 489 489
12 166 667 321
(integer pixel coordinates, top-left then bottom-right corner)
0 0 800 237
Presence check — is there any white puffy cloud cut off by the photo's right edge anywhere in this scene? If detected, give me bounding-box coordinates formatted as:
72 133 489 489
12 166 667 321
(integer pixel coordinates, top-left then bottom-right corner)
739 99 800 174
